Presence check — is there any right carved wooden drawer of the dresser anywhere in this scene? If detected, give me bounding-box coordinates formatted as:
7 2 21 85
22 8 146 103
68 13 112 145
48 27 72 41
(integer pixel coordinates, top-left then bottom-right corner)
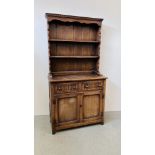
82 80 103 90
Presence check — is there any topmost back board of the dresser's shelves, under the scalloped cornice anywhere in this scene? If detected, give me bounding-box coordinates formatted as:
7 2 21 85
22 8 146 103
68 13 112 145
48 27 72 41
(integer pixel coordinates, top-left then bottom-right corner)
49 21 98 41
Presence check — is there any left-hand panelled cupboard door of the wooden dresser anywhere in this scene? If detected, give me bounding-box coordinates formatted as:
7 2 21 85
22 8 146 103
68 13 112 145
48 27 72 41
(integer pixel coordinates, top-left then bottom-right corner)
55 94 79 126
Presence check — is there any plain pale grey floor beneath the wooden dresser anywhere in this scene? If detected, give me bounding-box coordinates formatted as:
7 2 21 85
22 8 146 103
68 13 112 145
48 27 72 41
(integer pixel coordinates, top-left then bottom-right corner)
34 112 121 155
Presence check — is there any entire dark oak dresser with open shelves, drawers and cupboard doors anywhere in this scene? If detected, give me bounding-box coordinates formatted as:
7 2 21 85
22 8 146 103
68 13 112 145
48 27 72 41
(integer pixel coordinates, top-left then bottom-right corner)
46 13 107 134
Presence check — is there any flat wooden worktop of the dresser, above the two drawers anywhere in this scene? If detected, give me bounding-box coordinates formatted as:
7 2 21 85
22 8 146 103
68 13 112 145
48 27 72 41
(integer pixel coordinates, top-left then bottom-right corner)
48 74 107 82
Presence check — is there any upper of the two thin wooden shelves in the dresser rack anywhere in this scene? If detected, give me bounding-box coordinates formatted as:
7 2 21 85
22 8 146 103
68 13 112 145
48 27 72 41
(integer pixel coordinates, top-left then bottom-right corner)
49 39 100 43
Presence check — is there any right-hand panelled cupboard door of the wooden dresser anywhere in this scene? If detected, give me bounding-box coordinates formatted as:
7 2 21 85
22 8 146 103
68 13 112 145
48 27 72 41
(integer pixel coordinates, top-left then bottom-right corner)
82 91 103 121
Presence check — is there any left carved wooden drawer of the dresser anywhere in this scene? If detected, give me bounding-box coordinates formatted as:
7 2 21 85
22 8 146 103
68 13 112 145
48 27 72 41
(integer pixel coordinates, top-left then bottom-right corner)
54 82 79 94
